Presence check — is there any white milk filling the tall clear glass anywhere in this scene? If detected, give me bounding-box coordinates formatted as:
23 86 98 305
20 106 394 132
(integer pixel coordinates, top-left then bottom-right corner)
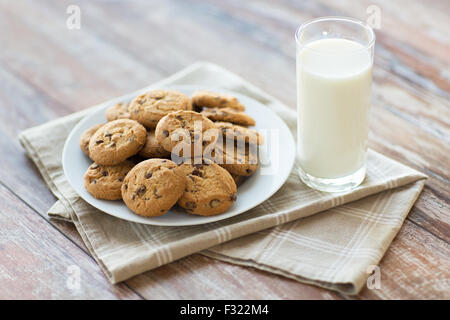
297 39 372 179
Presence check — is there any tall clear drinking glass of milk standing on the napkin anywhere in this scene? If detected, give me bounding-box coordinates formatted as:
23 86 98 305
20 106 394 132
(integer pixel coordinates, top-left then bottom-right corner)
295 17 375 192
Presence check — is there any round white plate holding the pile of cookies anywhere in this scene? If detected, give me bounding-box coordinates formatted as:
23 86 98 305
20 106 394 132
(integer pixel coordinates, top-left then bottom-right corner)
62 86 295 226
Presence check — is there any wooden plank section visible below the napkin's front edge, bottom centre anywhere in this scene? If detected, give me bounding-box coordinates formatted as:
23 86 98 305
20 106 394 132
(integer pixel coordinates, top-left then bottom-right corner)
127 254 342 299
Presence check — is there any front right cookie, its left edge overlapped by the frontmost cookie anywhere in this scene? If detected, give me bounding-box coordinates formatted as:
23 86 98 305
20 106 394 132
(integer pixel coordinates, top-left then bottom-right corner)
178 161 237 216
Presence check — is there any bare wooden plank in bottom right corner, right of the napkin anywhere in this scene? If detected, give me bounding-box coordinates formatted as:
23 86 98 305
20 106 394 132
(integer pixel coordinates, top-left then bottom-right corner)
357 221 450 300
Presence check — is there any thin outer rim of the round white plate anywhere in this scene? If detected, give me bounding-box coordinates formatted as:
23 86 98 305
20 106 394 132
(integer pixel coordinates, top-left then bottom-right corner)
61 84 296 227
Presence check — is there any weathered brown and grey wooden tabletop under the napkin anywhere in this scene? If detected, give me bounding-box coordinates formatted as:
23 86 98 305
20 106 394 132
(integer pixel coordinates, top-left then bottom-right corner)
0 0 450 299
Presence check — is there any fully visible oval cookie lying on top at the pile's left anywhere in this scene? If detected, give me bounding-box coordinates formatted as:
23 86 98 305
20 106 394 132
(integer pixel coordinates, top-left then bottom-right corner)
89 119 147 165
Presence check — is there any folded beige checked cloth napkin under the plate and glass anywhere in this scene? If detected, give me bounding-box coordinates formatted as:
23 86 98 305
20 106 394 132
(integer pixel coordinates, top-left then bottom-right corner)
19 62 426 294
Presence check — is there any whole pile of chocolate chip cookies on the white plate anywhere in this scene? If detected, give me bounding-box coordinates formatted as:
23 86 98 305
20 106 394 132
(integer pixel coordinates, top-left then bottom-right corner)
80 90 263 217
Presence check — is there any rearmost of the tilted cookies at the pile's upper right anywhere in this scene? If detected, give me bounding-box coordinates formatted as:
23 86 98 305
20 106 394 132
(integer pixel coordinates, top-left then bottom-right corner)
192 90 245 111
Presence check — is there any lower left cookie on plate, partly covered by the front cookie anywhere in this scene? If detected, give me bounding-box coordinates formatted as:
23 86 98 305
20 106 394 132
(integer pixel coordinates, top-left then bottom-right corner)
84 161 134 200
